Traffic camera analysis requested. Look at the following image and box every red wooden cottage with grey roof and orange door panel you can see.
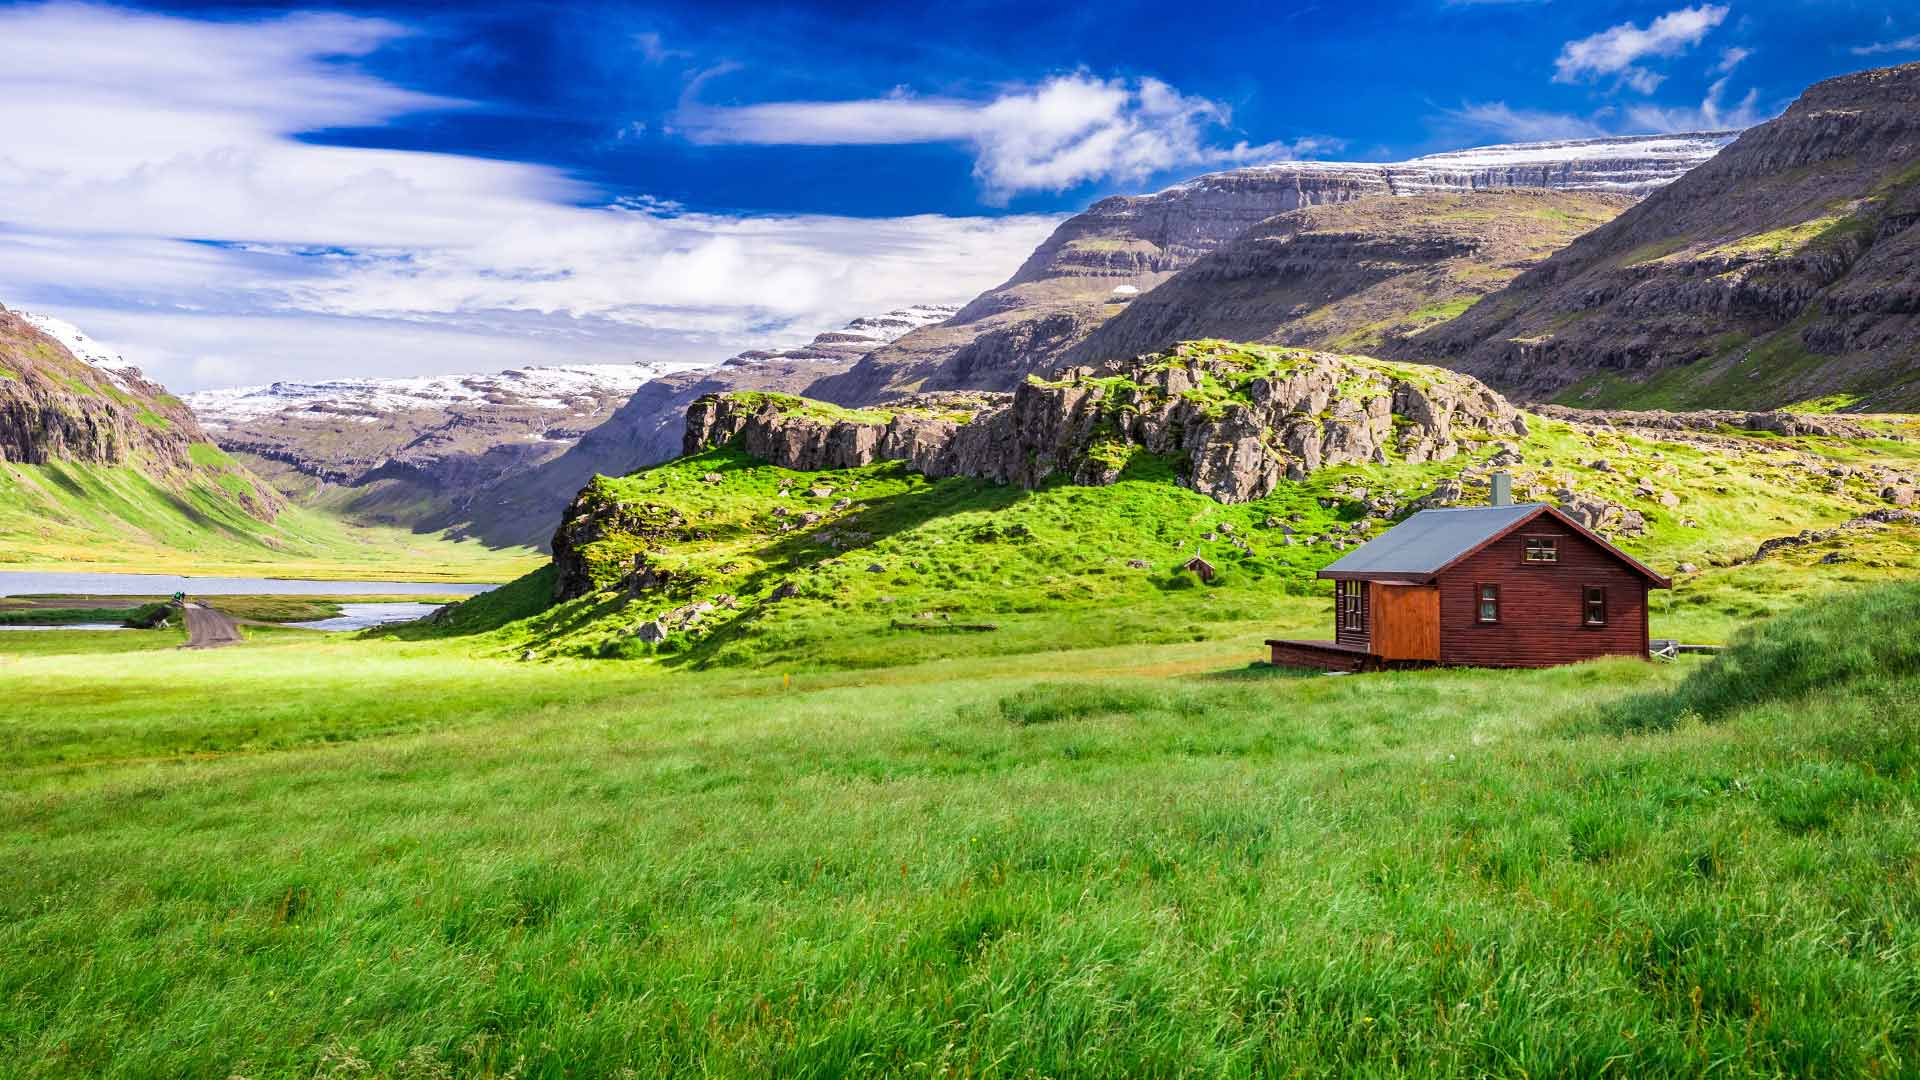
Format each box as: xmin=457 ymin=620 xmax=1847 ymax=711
xmin=1267 ymin=503 xmax=1672 ymax=671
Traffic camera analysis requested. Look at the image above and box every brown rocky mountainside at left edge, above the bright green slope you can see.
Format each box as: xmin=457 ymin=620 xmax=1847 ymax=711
xmin=0 ymin=307 xmax=284 ymax=521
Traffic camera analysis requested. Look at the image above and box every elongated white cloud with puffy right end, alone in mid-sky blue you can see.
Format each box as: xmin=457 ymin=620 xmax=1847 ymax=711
xmin=678 ymin=73 xmax=1336 ymax=202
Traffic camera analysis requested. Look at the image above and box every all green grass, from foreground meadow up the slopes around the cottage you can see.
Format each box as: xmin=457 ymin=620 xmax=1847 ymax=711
xmin=11 ymin=368 xmax=1920 ymax=1080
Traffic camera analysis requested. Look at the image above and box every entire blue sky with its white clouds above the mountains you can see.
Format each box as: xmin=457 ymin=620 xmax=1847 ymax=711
xmin=0 ymin=0 xmax=1920 ymax=388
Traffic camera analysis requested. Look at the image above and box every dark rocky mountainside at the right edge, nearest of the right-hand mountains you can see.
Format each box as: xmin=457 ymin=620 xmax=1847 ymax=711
xmin=1421 ymin=65 xmax=1920 ymax=409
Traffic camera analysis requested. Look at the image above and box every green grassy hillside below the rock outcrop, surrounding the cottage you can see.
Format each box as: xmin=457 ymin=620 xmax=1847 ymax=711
xmin=461 ymin=390 xmax=1920 ymax=671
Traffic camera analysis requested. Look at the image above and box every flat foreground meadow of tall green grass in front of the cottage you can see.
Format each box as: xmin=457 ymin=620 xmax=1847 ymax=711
xmin=0 ymin=586 xmax=1920 ymax=1078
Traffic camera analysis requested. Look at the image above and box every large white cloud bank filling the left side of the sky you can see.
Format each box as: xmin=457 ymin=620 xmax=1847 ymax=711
xmin=0 ymin=4 xmax=1056 ymax=390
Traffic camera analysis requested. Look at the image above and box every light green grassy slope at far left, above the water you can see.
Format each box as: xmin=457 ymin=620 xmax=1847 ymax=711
xmin=0 ymin=448 xmax=540 ymax=580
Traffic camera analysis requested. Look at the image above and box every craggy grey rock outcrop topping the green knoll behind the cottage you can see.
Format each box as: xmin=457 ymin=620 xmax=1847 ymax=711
xmin=685 ymin=342 xmax=1526 ymax=502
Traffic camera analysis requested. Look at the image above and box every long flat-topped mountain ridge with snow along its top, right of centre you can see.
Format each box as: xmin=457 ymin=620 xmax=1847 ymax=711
xmin=806 ymin=133 xmax=1730 ymax=404
